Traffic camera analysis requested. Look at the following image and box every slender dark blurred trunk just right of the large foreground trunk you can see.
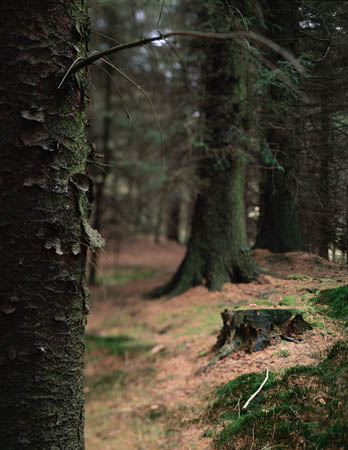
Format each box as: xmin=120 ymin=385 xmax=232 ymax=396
xmin=88 ymin=75 xmax=112 ymax=284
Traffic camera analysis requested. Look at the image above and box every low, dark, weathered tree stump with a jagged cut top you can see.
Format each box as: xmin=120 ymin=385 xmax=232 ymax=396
xmin=213 ymin=309 xmax=312 ymax=356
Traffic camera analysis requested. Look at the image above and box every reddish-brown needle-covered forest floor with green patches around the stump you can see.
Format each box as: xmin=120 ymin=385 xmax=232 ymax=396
xmin=85 ymin=237 xmax=348 ymax=450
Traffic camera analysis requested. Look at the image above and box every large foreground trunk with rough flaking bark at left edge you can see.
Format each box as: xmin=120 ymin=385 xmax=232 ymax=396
xmin=0 ymin=0 xmax=93 ymax=450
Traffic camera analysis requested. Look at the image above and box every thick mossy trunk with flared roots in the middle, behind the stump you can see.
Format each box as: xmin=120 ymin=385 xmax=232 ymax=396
xmin=150 ymin=2 xmax=256 ymax=296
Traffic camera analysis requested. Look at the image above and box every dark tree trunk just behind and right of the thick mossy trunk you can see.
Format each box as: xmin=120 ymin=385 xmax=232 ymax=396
xmin=255 ymin=0 xmax=304 ymax=253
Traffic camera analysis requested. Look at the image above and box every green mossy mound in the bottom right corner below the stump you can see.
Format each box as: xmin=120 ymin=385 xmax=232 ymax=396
xmin=206 ymin=342 xmax=348 ymax=450
